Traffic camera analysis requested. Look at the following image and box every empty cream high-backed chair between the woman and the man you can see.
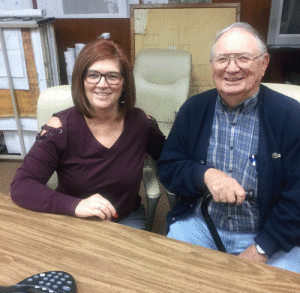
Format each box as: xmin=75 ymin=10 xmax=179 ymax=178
xmin=134 ymin=48 xmax=192 ymax=229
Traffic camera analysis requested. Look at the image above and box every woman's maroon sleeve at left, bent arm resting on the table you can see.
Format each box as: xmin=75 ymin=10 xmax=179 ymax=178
xmin=10 ymin=125 xmax=80 ymax=215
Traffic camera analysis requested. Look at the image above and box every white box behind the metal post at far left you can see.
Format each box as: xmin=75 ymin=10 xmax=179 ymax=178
xmin=0 ymin=118 xmax=38 ymax=154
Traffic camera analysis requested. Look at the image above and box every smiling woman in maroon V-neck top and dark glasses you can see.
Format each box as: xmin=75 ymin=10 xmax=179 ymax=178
xmin=11 ymin=39 xmax=165 ymax=228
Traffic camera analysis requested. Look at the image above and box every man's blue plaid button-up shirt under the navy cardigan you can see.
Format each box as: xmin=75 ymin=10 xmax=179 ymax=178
xmin=196 ymin=93 xmax=259 ymax=232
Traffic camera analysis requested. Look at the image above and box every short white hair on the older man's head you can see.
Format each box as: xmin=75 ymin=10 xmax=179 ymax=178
xmin=210 ymin=22 xmax=267 ymax=59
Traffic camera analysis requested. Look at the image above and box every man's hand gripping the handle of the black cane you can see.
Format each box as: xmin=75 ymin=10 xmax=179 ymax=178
xmin=204 ymin=168 xmax=246 ymax=205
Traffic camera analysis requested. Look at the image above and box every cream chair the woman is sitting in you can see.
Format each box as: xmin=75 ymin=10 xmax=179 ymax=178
xmin=37 ymin=85 xmax=159 ymax=231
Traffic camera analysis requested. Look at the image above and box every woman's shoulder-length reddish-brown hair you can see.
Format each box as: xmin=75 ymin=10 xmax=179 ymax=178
xmin=71 ymin=38 xmax=136 ymax=118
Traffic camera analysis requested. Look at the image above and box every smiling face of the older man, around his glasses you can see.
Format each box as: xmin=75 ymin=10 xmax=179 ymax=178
xmin=211 ymin=28 xmax=269 ymax=107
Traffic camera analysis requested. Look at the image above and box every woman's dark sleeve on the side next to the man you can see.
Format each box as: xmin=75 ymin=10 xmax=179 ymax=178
xmin=147 ymin=117 xmax=166 ymax=161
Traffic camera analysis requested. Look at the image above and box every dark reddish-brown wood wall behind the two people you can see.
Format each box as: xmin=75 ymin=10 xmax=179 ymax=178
xmin=54 ymin=0 xmax=274 ymax=84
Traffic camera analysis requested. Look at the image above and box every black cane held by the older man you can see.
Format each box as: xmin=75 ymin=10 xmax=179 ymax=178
xmin=201 ymin=190 xmax=254 ymax=252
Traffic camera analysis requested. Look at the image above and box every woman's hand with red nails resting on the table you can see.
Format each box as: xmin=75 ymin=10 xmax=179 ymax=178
xmin=75 ymin=193 xmax=118 ymax=220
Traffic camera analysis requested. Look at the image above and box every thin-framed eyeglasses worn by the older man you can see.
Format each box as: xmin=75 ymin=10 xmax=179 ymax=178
xmin=211 ymin=53 xmax=265 ymax=70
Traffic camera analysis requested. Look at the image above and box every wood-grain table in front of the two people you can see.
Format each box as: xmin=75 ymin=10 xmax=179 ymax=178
xmin=0 ymin=194 xmax=300 ymax=293
